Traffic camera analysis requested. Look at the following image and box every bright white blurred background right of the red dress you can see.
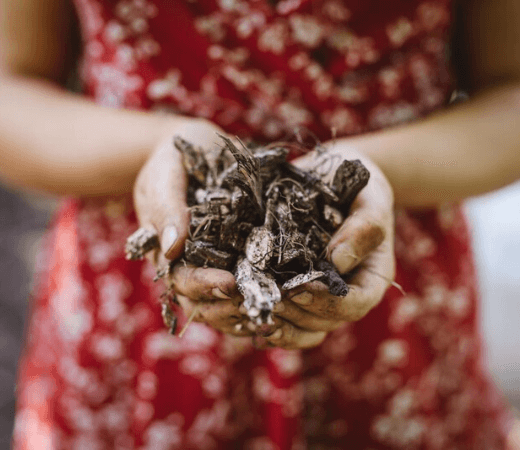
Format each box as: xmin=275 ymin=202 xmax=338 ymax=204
xmin=466 ymin=183 xmax=520 ymax=407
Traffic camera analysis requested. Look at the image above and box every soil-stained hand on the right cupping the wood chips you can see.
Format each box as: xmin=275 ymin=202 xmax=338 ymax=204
xmin=266 ymin=144 xmax=395 ymax=349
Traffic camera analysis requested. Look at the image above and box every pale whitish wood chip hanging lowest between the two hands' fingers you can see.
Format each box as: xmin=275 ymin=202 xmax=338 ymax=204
xmin=235 ymin=258 xmax=282 ymax=325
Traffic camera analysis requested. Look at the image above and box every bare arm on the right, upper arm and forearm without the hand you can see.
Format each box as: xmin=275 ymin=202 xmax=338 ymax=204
xmin=336 ymin=0 xmax=520 ymax=207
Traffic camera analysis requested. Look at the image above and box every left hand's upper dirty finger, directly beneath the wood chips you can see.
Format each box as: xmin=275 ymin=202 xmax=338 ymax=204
xmin=169 ymin=263 xmax=241 ymax=303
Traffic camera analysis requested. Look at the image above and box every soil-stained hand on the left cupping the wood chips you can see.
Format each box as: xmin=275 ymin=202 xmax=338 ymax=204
xmin=134 ymin=119 xmax=251 ymax=336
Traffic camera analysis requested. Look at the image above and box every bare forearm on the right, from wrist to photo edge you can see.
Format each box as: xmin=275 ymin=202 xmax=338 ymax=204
xmin=336 ymin=85 xmax=520 ymax=207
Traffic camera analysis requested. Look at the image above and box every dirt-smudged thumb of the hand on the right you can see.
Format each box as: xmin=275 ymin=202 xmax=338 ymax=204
xmin=327 ymin=199 xmax=386 ymax=273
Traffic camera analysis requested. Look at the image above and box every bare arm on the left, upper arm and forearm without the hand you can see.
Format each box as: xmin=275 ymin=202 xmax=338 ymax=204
xmin=0 ymin=0 xmax=185 ymax=196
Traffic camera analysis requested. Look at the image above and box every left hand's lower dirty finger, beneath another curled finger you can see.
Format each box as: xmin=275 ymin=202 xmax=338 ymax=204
xmin=177 ymin=295 xmax=253 ymax=336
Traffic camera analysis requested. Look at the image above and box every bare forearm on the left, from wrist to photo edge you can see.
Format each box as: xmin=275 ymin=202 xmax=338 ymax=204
xmin=0 ymin=77 xmax=186 ymax=196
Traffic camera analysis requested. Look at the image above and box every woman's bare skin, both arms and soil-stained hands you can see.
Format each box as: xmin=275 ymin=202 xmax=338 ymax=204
xmin=0 ymin=0 xmax=520 ymax=348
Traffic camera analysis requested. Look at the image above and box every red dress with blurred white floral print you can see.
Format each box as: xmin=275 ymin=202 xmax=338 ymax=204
xmin=14 ymin=0 xmax=509 ymax=450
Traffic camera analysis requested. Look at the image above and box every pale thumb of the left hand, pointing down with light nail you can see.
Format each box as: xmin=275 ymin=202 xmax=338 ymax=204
xmin=134 ymin=139 xmax=189 ymax=259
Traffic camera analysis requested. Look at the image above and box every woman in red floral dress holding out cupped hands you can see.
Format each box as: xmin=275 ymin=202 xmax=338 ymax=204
xmin=0 ymin=0 xmax=520 ymax=449
